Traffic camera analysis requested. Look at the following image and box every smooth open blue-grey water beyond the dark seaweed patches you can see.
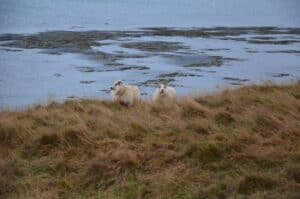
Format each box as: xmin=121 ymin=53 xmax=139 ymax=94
xmin=0 ymin=0 xmax=300 ymax=33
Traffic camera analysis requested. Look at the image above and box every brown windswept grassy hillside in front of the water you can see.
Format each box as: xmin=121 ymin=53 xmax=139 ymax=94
xmin=0 ymin=83 xmax=300 ymax=199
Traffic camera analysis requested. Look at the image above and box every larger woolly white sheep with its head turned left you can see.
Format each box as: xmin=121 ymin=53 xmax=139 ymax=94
xmin=111 ymin=80 xmax=141 ymax=106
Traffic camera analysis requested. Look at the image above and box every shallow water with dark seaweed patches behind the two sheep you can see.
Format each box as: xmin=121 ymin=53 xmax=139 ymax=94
xmin=0 ymin=27 xmax=300 ymax=107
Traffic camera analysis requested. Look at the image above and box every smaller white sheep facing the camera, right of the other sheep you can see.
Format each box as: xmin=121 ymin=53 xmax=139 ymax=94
xmin=152 ymin=84 xmax=176 ymax=101
